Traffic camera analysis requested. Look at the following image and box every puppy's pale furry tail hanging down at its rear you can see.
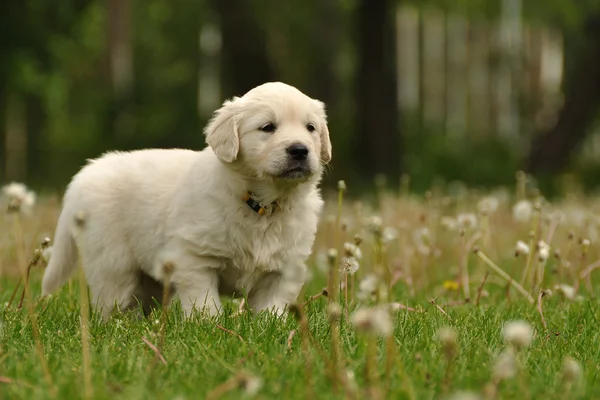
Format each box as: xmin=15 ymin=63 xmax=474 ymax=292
xmin=42 ymin=210 xmax=78 ymax=296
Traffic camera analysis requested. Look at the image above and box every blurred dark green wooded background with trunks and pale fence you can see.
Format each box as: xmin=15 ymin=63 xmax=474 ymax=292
xmin=0 ymin=0 xmax=600 ymax=193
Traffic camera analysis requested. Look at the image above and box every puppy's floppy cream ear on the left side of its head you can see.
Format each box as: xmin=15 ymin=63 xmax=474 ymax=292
xmin=204 ymin=97 xmax=240 ymax=162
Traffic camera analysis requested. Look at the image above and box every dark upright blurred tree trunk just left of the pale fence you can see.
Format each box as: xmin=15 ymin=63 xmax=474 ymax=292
xmin=354 ymin=0 xmax=401 ymax=179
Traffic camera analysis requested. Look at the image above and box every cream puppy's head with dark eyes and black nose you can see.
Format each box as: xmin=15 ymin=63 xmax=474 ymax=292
xmin=204 ymin=82 xmax=331 ymax=182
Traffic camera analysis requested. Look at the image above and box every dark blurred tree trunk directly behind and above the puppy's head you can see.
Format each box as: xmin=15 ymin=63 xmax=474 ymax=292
xmin=210 ymin=0 xmax=274 ymax=98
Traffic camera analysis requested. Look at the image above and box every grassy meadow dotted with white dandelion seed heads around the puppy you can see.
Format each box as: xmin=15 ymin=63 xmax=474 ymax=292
xmin=0 ymin=173 xmax=600 ymax=400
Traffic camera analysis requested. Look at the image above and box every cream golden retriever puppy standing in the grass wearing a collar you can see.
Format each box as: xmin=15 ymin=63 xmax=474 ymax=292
xmin=42 ymin=82 xmax=331 ymax=318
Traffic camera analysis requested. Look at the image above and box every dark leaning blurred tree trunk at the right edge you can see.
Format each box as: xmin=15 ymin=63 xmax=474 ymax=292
xmin=525 ymin=15 xmax=600 ymax=174
